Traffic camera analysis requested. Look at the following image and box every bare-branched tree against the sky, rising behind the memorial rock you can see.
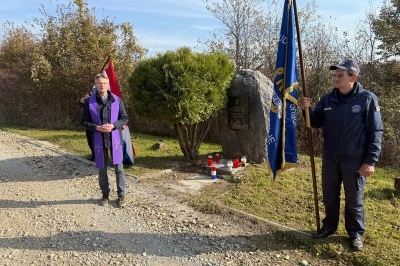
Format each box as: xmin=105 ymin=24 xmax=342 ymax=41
xmin=203 ymin=0 xmax=268 ymax=70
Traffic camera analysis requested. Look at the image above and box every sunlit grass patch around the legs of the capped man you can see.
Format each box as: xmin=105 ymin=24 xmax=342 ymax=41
xmin=209 ymin=155 xmax=400 ymax=265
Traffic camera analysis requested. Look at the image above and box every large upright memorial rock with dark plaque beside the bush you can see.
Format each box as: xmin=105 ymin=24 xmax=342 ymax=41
xmin=217 ymin=70 xmax=273 ymax=163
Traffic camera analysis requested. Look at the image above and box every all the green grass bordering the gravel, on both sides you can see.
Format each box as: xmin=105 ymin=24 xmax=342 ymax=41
xmin=0 ymin=126 xmax=400 ymax=266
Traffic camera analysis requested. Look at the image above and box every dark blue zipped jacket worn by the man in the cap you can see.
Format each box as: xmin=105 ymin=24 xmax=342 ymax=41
xmin=310 ymin=82 xmax=383 ymax=165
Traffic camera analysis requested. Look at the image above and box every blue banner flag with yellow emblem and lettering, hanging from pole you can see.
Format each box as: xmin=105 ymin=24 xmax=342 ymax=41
xmin=266 ymin=0 xmax=299 ymax=179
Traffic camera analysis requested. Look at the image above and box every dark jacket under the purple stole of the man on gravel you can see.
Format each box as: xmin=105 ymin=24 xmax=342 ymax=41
xmin=81 ymin=91 xmax=128 ymax=148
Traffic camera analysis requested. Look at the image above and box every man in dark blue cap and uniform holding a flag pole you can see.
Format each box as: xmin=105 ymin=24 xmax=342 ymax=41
xmin=300 ymin=60 xmax=383 ymax=250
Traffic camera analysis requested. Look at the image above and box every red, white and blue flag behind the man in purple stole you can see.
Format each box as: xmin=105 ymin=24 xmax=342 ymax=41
xmin=105 ymin=59 xmax=136 ymax=165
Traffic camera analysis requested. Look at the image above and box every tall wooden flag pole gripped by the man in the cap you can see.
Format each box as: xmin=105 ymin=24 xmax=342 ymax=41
xmin=292 ymin=0 xmax=321 ymax=232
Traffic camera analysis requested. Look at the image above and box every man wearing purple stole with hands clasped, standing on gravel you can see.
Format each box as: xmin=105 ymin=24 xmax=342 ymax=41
xmin=81 ymin=74 xmax=128 ymax=207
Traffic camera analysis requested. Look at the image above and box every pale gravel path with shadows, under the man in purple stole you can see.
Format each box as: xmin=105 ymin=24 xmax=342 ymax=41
xmin=0 ymin=131 xmax=336 ymax=266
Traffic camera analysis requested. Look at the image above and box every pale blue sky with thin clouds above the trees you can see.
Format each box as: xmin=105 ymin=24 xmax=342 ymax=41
xmin=0 ymin=0 xmax=384 ymax=56
